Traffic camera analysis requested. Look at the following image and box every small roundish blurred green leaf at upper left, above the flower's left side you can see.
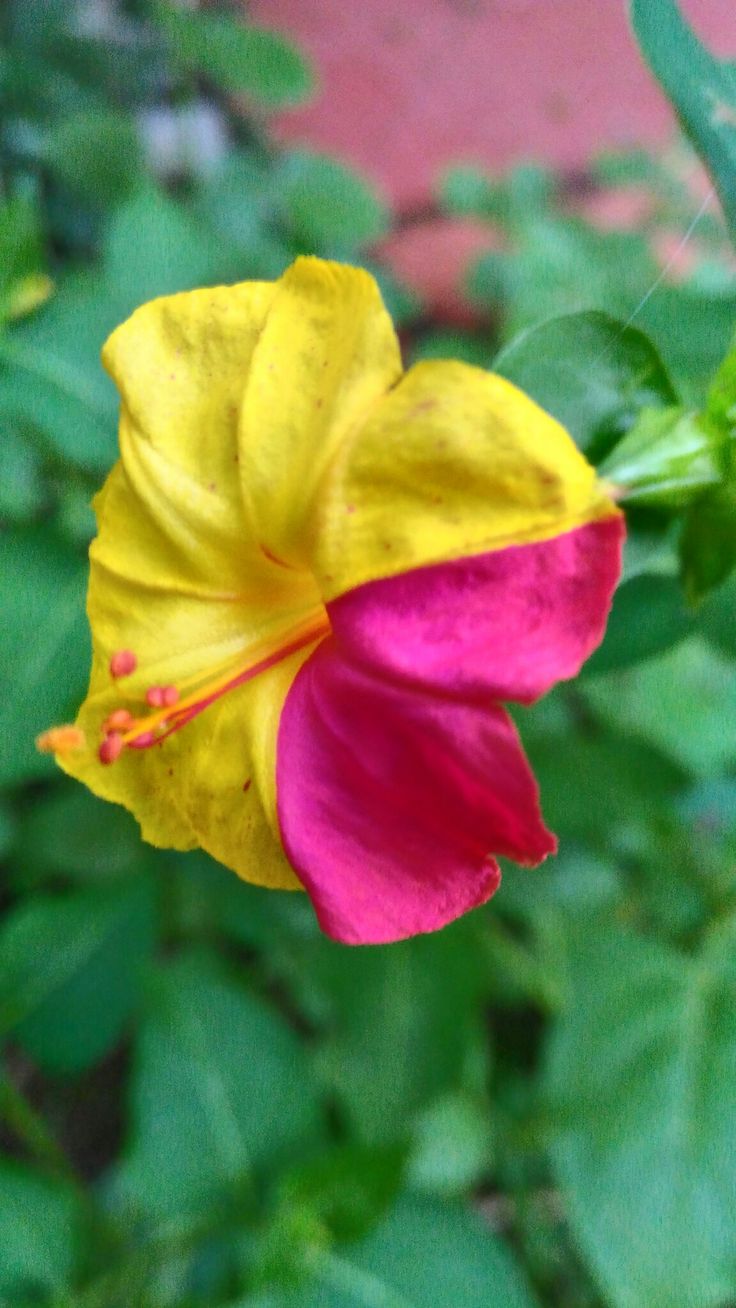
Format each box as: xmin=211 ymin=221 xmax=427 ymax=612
xmin=43 ymin=110 xmax=144 ymax=208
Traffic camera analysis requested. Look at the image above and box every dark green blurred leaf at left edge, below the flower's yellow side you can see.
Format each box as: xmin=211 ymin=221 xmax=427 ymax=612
xmin=0 ymin=879 xmax=154 ymax=1073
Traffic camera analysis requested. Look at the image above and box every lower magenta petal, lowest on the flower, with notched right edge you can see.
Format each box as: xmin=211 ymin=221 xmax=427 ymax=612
xmin=277 ymin=638 xmax=554 ymax=944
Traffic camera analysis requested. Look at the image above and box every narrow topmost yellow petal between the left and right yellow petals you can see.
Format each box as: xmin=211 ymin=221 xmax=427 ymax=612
xmin=241 ymin=259 xmax=401 ymax=566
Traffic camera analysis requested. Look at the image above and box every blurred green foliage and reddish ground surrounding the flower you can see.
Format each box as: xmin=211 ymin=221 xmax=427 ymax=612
xmin=0 ymin=0 xmax=736 ymax=1308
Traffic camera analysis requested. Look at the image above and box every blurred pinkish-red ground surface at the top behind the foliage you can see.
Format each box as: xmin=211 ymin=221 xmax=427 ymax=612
xmin=248 ymin=0 xmax=736 ymax=313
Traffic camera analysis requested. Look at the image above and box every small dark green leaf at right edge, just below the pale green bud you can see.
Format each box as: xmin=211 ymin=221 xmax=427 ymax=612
xmin=680 ymin=480 xmax=736 ymax=603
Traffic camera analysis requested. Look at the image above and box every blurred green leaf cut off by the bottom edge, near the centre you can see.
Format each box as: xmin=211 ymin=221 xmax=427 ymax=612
xmin=270 ymin=1198 xmax=537 ymax=1308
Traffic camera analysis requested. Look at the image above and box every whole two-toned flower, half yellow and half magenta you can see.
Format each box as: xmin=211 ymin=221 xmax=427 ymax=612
xmin=44 ymin=258 xmax=624 ymax=943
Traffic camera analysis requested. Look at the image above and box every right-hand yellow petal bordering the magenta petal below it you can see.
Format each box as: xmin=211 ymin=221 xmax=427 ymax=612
xmin=312 ymin=361 xmax=617 ymax=599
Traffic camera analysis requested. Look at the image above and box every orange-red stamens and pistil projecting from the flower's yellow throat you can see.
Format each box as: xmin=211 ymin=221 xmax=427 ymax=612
xmin=98 ymin=610 xmax=329 ymax=764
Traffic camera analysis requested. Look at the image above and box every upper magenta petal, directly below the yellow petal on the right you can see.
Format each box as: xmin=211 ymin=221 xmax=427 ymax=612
xmin=329 ymin=515 xmax=624 ymax=704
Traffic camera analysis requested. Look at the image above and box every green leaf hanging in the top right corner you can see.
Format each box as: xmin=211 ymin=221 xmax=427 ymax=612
xmin=631 ymin=0 xmax=736 ymax=241
